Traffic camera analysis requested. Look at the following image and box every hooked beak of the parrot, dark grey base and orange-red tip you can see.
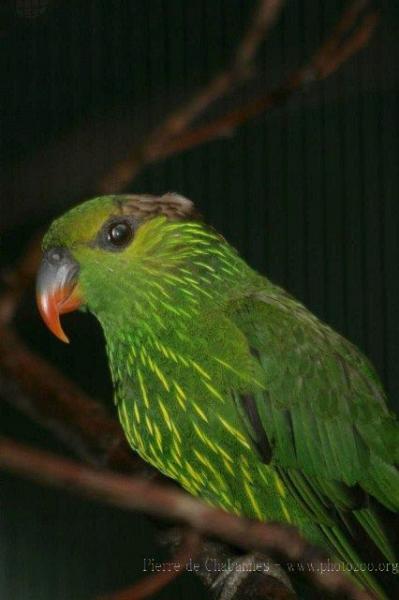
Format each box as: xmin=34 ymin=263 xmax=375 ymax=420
xmin=36 ymin=247 xmax=82 ymax=343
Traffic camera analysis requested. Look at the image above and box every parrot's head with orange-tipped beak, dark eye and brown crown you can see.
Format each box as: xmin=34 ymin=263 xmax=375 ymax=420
xmin=37 ymin=193 xmax=230 ymax=342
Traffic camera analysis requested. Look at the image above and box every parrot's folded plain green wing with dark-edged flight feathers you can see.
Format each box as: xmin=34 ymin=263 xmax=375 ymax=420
xmin=230 ymin=287 xmax=399 ymax=595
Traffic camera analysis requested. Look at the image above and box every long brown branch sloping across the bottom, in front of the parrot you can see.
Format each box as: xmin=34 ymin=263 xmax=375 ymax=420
xmin=0 ymin=437 xmax=372 ymax=600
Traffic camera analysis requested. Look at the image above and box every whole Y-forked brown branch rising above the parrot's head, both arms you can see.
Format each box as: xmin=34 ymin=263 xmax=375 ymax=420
xmin=98 ymin=0 xmax=379 ymax=193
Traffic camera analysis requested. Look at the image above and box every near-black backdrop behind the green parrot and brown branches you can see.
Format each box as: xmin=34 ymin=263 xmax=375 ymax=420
xmin=0 ymin=0 xmax=399 ymax=600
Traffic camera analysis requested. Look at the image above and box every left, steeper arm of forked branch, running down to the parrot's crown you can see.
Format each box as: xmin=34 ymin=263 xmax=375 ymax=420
xmin=99 ymin=0 xmax=284 ymax=193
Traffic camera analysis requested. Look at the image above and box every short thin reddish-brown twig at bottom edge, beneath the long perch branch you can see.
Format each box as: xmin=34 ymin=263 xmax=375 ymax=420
xmin=98 ymin=530 xmax=202 ymax=600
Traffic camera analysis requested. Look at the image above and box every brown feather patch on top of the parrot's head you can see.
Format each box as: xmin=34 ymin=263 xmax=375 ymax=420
xmin=115 ymin=193 xmax=201 ymax=221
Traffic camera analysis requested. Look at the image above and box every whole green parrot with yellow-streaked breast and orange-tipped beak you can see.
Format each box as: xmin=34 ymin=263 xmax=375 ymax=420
xmin=37 ymin=193 xmax=399 ymax=598
